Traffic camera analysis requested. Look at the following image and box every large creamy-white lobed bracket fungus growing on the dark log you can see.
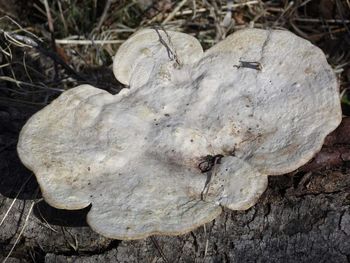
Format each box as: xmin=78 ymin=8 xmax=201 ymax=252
xmin=18 ymin=29 xmax=341 ymax=239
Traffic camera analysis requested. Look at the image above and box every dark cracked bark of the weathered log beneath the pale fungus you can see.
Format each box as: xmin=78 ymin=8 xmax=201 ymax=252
xmin=0 ymin=108 xmax=350 ymax=262
